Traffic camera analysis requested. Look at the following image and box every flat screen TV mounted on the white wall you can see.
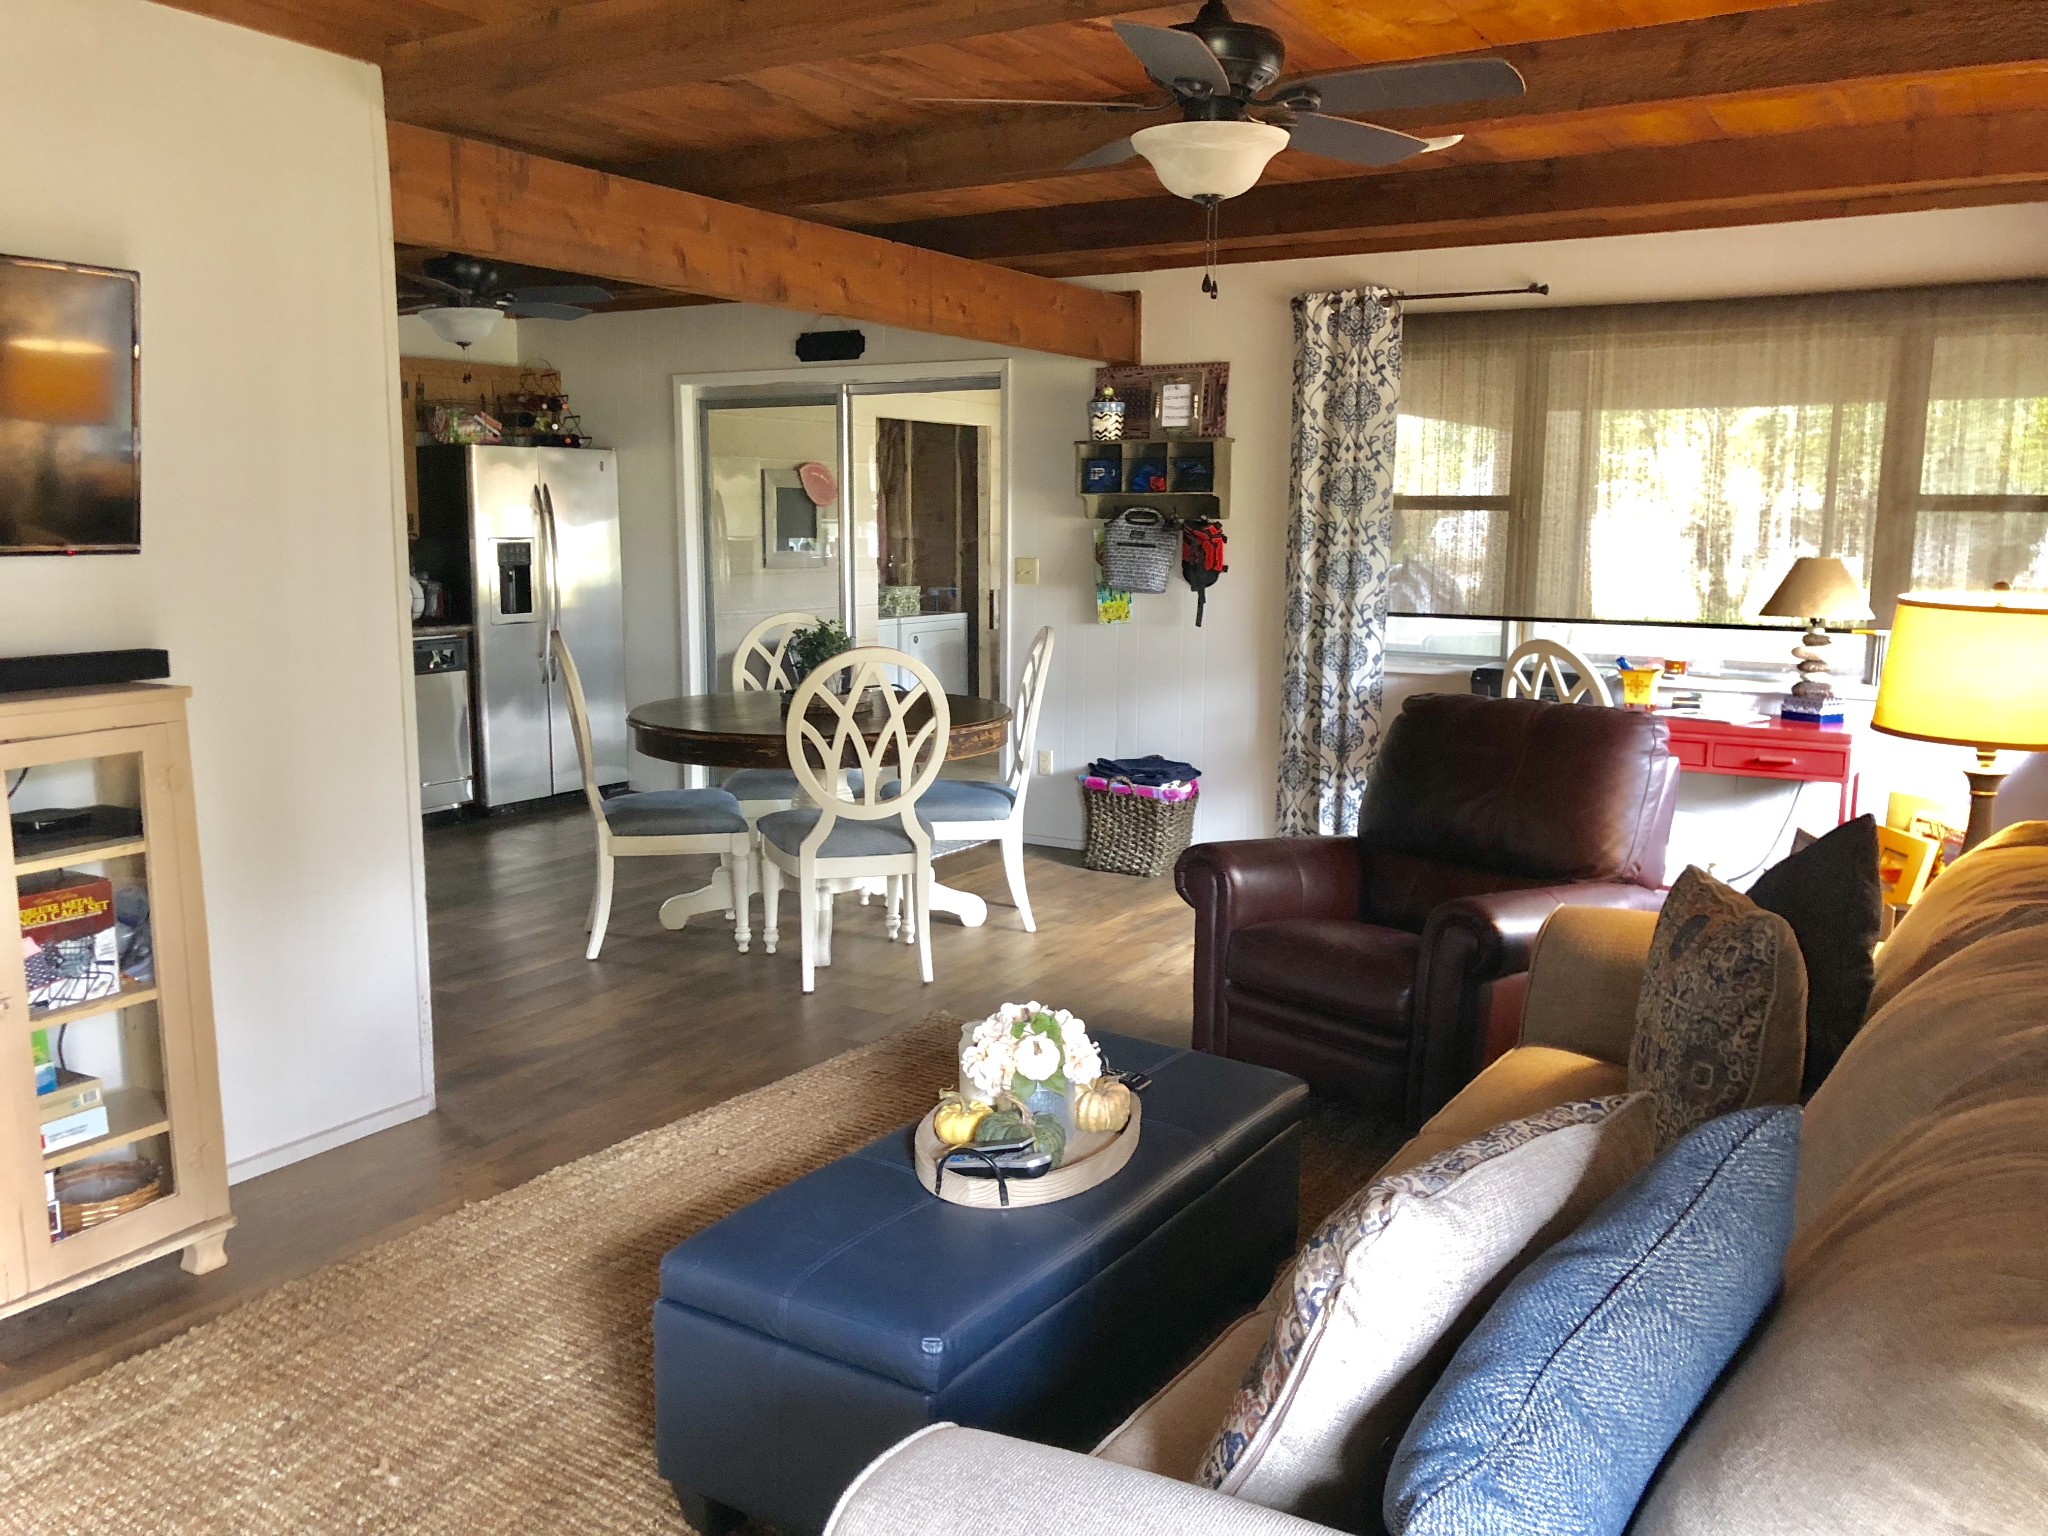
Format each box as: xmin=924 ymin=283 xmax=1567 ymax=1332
xmin=0 ymin=256 xmax=141 ymax=555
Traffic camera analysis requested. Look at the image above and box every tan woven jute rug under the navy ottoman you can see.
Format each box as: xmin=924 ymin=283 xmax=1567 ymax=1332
xmin=0 ymin=1016 xmax=1399 ymax=1536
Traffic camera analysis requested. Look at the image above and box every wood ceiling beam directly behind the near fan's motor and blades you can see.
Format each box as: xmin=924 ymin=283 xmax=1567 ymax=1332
xmin=627 ymin=0 xmax=2048 ymax=209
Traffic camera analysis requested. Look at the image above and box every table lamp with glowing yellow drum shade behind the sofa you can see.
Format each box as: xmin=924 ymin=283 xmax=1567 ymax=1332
xmin=1870 ymin=588 xmax=2048 ymax=852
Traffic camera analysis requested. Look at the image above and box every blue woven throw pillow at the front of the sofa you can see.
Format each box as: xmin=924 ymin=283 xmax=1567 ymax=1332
xmin=1386 ymin=1108 xmax=1800 ymax=1536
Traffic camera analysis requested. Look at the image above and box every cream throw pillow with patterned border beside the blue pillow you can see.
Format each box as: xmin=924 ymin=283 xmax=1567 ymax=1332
xmin=1198 ymin=1094 xmax=1651 ymax=1524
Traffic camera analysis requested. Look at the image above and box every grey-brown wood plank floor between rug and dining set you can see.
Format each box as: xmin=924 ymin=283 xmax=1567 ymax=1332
xmin=0 ymin=807 xmax=1192 ymax=1409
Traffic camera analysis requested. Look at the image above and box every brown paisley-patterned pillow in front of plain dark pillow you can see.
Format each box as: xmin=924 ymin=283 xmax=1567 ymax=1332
xmin=1628 ymin=868 xmax=1806 ymax=1147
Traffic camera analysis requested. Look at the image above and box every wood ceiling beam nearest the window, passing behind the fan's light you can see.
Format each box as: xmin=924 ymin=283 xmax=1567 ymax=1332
xmin=889 ymin=113 xmax=2048 ymax=274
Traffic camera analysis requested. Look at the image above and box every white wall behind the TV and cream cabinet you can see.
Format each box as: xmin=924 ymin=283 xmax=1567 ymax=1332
xmin=0 ymin=0 xmax=432 ymax=1176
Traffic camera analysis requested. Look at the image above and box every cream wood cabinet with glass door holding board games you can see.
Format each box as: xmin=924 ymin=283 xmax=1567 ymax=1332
xmin=0 ymin=686 xmax=233 ymax=1317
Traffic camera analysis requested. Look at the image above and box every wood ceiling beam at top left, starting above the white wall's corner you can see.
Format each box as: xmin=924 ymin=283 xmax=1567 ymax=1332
xmin=385 ymin=0 xmax=1133 ymax=127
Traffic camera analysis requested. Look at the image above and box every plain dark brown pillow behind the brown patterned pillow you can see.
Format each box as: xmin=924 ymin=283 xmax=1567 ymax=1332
xmin=1749 ymin=815 xmax=1884 ymax=1098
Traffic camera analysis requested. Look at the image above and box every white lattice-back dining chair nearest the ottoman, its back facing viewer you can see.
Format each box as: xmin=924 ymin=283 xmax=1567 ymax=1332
xmin=760 ymin=645 xmax=952 ymax=991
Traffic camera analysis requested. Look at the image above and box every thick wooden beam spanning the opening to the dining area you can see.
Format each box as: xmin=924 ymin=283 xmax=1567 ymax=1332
xmin=389 ymin=123 xmax=1139 ymax=362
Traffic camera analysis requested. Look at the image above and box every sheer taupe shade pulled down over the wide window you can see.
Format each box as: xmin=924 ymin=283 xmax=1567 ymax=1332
xmin=1391 ymin=285 xmax=2048 ymax=633
